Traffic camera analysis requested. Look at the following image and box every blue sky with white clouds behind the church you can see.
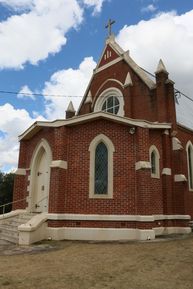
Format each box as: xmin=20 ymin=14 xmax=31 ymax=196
xmin=0 ymin=0 xmax=193 ymax=171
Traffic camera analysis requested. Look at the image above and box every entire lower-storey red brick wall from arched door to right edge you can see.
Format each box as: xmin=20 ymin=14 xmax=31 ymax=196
xmin=14 ymin=116 xmax=193 ymax=224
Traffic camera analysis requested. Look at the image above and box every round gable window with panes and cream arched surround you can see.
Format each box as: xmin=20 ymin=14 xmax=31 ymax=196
xmin=94 ymin=88 xmax=124 ymax=116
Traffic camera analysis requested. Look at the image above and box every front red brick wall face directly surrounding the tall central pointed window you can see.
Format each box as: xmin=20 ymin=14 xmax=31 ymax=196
xmin=65 ymin=120 xmax=135 ymax=214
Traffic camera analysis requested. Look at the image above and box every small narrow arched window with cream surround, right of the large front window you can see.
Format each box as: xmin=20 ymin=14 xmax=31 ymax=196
xmin=149 ymin=145 xmax=160 ymax=178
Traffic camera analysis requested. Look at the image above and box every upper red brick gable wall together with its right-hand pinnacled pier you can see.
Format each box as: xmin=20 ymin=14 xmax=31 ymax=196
xmin=79 ymin=60 xmax=176 ymax=129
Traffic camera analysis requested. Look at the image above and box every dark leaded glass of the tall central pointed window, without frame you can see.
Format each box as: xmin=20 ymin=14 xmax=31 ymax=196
xmin=94 ymin=142 xmax=108 ymax=194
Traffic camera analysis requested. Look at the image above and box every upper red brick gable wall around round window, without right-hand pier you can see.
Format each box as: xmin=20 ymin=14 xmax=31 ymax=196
xmin=79 ymin=61 xmax=161 ymax=121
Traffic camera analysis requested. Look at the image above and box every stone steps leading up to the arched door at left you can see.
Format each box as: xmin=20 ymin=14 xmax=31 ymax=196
xmin=0 ymin=213 xmax=36 ymax=244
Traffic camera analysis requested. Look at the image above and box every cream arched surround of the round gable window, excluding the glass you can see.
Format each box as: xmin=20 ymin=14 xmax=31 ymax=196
xmin=94 ymin=87 xmax=124 ymax=116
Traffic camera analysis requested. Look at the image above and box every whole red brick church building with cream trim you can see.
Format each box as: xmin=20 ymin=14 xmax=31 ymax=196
xmin=13 ymin=34 xmax=193 ymax=243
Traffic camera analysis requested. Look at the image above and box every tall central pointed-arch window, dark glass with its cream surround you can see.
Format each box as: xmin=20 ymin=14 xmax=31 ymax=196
xmin=89 ymin=134 xmax=114 ymax=198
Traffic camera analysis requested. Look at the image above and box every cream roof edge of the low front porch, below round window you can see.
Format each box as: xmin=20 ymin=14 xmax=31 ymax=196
xmin=19 ymin=112 xmax=171 ymax=141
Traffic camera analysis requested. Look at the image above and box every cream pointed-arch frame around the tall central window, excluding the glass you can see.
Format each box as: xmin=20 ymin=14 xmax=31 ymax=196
xmin=89 ymin=134 xmax=115 ymax=199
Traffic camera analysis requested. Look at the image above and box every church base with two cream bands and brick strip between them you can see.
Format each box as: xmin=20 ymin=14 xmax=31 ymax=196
xmin=47 ymin=214 xmax=191 ymax=241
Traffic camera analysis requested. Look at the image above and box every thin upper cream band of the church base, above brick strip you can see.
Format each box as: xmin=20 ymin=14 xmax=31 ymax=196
xmin=47 ymin=213 xmax=191 ymax=222
